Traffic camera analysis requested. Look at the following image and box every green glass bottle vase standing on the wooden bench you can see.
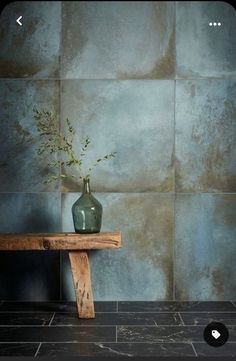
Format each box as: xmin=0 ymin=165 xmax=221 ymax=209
xmin=72 ymin=179 xmax=102 ymax=233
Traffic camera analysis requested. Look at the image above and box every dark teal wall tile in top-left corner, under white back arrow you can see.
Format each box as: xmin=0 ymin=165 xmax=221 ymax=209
xmin=0 ymin=1 xmax=61 ymax=79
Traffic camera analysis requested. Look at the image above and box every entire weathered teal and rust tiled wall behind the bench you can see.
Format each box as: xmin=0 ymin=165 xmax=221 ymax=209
xmin=0 ymin=1 xmax=236 ymax=300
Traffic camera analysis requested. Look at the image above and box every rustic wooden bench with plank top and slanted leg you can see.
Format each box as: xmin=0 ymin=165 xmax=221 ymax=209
xmin=0 ymin=232 xmax=121 ymax=318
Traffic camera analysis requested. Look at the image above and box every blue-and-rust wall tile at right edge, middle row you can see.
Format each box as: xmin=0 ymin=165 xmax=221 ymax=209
xmin=175 ymin=79 xmax=236 ymax=192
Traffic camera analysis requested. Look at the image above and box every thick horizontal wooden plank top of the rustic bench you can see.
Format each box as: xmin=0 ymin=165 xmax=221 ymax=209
xmin=0 ymin=232 xmax=121 ymax=251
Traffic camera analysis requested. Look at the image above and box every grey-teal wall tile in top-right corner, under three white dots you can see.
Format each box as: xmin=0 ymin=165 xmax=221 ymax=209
xmin=176 ymin=1 xmax=236 ymax=78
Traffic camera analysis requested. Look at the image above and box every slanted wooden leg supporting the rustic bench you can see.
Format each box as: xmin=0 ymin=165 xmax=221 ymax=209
xmin=69 ymin=251 xmax=95 ymax=318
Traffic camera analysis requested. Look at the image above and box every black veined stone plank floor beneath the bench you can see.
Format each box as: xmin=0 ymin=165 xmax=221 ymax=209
xmin=0 ymin=301 xmax=236 ymax=357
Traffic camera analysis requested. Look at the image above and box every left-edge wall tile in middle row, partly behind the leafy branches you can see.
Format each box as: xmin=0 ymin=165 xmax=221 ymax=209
xmin=0 ymin=79 xmax=59 ymax=192
